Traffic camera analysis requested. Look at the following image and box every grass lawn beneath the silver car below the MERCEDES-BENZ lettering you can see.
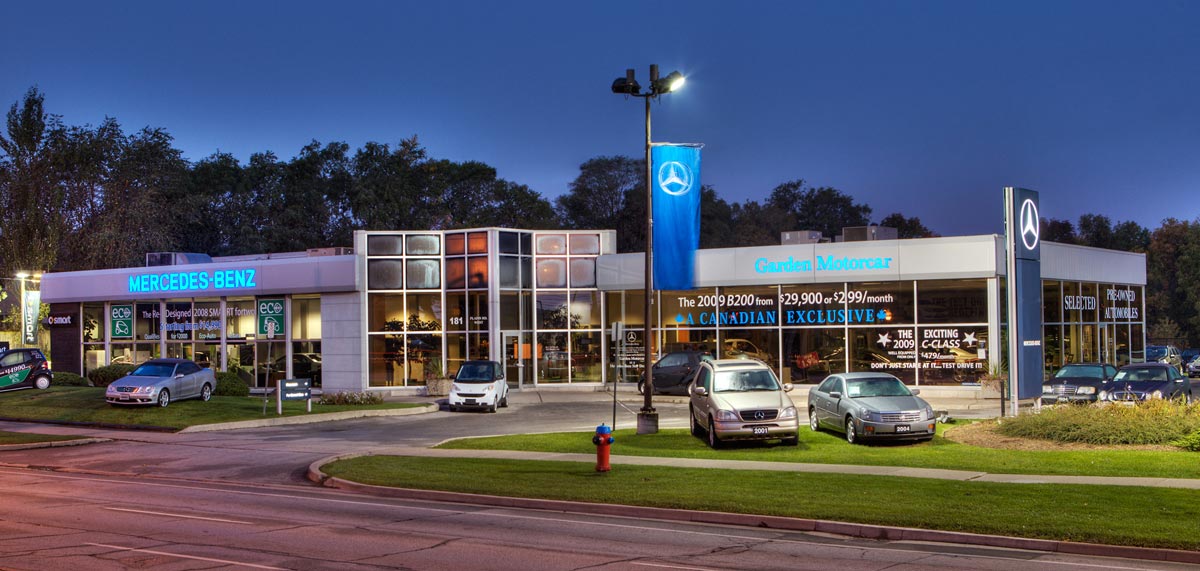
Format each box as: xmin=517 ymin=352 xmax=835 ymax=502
xmin=0 ymin=386 xmax=420 ymax=429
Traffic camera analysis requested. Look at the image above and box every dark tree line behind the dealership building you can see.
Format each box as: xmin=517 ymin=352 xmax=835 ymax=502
xmin=0 ymin=88 xmax=1200 ymax=344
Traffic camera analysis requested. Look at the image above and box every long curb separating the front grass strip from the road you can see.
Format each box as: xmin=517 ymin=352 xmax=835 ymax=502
xmin=306 ymin=452 xmax=1200 ymax=564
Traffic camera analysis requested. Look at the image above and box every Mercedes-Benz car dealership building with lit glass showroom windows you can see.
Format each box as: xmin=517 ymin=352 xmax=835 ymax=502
xmin=41 ymin=228 xmax=1146 ymax=393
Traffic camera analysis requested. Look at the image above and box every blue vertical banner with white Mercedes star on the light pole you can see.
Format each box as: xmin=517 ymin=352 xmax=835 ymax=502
xmin=650 ymin=144 xmax=701 ymax=289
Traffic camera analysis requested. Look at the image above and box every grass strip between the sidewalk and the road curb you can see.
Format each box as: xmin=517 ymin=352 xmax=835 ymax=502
xmin=323 ymin=455 xmax=1200 ymax=549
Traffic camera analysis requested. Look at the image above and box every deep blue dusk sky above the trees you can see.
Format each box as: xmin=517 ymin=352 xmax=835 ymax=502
xmin=0 ymin=0 xmax=1200 ymax=235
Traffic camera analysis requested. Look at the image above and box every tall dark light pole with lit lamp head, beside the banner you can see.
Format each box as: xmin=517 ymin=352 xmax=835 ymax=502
xmin=612 ymin=64 xmax=684 ymax=434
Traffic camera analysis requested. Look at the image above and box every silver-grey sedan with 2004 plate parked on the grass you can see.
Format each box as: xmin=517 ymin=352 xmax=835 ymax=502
xmin=809 ymin=373 xmax=937 ymax=444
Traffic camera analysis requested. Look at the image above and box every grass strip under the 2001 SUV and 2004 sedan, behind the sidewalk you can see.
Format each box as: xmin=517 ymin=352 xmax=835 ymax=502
xmin=439 ymin=423 xmax=1200 ymax=479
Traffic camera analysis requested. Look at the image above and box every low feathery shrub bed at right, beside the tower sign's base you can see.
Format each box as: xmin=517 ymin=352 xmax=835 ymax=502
xmin=997 ymin=399 xmax=1200 ymax=445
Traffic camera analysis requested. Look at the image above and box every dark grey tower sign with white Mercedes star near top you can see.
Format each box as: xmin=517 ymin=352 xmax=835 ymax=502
xmin=1004 ymin=187 xmax=1044 ymax=416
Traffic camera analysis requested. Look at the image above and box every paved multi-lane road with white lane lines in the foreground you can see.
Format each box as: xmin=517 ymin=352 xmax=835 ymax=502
xmin=0 ymin=468 xmax=1200 ymax=571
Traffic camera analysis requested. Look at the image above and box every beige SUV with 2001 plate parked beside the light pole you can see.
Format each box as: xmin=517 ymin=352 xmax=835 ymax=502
xmin=688 ymin=359 xmax=800 ymax=449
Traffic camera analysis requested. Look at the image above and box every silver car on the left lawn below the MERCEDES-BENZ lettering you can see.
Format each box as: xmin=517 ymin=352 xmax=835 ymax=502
xmin=104 ymin=359 xmax=217 ymax=407
